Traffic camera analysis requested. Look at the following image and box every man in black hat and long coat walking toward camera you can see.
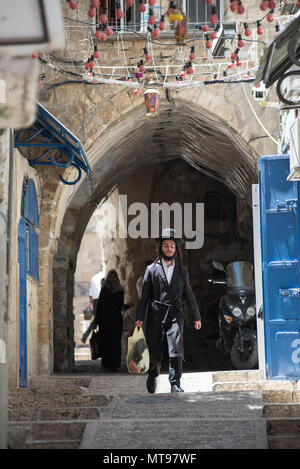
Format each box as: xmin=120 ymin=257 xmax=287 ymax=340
xmin=136 ymin=228 xmax=201 ymax=393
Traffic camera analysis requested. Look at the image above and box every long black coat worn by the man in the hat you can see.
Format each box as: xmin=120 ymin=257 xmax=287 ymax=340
xmin=136 ymin=259 xmax=201 ymax=359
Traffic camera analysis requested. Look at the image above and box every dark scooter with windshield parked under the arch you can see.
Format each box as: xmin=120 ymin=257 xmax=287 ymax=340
xmin=208 ymin=261 xmax=258 ymax=370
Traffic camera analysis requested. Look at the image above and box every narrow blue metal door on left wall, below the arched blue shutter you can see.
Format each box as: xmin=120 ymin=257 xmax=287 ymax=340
xmin=18 ymin=218 xmax=27 ymax=387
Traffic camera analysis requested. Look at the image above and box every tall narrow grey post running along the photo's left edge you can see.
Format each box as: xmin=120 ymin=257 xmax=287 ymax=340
xmin=0 ymin=130 xmax=14 ymax=449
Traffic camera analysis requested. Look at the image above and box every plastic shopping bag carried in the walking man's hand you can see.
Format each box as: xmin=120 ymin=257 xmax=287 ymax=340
xmin=126 ymin=327 xmax=150 ymax=374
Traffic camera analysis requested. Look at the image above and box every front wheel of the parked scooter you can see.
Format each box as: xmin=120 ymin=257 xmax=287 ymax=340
xmin=231 ymin=329 xmax=258 ymax=370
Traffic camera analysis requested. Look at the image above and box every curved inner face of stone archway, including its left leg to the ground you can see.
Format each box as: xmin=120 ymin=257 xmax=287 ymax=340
xmin=53 ymin=100 xmax=256 ymax=371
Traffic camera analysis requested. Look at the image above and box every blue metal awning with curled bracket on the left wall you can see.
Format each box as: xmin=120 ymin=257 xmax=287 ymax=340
xmin=15 ymin=103 xmax=91 ymax=185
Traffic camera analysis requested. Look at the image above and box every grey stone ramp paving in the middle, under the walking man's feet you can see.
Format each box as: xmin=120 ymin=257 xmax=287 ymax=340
xmin=79 ymin=372 xmax=268 ymax=450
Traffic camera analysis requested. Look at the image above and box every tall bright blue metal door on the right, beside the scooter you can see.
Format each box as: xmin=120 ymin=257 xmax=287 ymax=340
xmin=258 ymin=155 xmax=300 ymax=380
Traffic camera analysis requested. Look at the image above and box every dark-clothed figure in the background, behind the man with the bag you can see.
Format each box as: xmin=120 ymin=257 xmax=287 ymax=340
xmin=94 ymin=270 xmax=131 ymax=370
